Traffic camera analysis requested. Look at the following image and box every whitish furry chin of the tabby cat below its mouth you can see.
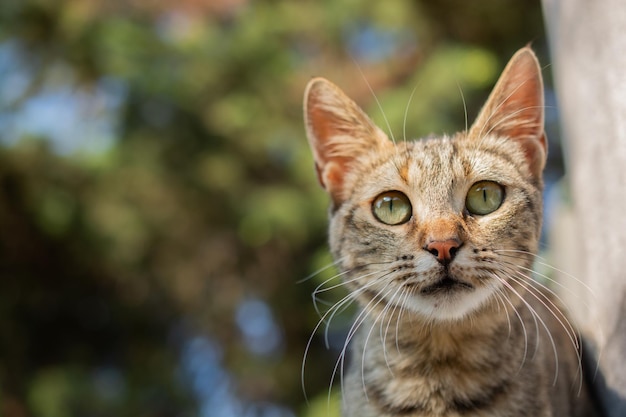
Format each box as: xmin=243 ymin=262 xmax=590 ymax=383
xmin=404 ymin=277 xmax=492 ymax=321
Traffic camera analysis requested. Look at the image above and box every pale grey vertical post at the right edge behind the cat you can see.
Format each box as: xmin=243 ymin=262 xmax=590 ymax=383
xmin=543 ymin=0 xmax=626 ymax=417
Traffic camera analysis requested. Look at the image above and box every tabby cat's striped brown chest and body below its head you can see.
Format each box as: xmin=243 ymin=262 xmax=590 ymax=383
xmin=343 ymin=296 xmax=572 ymax=417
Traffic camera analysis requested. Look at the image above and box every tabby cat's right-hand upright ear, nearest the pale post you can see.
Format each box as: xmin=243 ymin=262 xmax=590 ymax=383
xmin=469 ymin=47 xmax=547 ymax=177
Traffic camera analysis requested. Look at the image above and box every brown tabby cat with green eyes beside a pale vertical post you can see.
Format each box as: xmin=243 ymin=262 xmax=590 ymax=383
xmin=304 ymin=47 xmax=597 ymax=417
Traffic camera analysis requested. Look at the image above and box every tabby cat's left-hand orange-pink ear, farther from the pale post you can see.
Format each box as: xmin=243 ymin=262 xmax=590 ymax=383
xmin=304 ymin=78 xmax=391 ymax=204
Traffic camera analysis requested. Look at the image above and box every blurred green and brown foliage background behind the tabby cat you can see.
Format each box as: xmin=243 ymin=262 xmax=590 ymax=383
xmin=0 ymin=0 xmax=562 ymax=417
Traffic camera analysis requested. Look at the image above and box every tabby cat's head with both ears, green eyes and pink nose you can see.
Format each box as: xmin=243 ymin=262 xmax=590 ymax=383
xmin=304 ymin=48 xmax=547 ymax=320
